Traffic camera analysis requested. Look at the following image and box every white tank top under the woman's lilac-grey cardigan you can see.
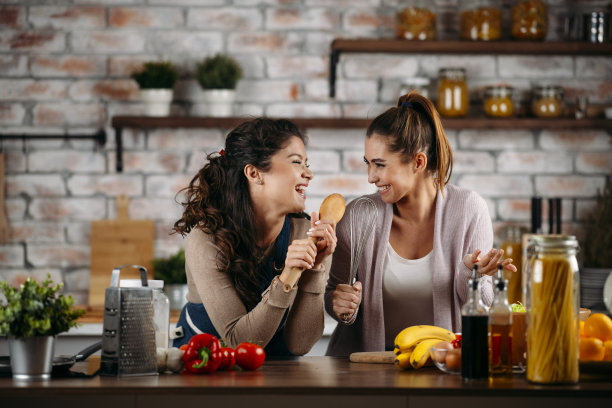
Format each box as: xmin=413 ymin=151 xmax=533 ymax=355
xmin=383 ymin=243 xmax=434 ymax=349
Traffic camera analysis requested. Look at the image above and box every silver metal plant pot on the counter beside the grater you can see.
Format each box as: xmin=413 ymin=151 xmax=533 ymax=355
xmin=8 ymin=336 xmax=55 ymax=380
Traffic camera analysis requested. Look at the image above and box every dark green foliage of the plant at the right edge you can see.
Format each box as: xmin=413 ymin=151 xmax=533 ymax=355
xmin=582 ymin=181 xmax=612 ymax=268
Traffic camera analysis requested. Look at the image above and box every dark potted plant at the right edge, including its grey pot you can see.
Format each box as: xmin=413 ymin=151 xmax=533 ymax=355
xmin=580 ymin=182 xmax=612 ymax=310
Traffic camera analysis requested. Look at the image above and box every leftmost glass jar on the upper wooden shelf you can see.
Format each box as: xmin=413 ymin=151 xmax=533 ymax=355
xmin=395 ymin=0 xmax=436 ymax=40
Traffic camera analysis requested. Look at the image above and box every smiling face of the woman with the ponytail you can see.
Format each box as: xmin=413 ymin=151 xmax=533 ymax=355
xmin=363 ymin=134 xmax=416 ymax=204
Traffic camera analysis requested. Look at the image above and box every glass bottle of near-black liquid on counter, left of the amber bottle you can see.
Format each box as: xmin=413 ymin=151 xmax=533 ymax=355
xmin=461 ymin=265 xmax=489 ymax=380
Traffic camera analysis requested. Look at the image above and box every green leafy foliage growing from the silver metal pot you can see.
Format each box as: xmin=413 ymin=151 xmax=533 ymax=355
xmin=0 ymin=275 xmax=85 ymax=338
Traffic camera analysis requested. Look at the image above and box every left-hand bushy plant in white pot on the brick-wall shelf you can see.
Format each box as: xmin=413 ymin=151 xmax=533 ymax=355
xmin=132 ymin=61 xmax=178 ymax=116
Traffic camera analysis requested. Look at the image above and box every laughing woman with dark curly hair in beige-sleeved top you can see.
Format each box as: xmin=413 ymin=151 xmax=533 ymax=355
xmin=174 ymin=118 xmax=336 ymax=356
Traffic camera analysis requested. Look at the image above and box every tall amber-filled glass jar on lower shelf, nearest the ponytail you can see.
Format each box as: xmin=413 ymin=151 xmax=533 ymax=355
xmin=437 ymin=68 xmax=470 ymax=117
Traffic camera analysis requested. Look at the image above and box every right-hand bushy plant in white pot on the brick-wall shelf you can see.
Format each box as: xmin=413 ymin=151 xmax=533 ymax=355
xmin=194 ymin=54 xmax=242 ymax=116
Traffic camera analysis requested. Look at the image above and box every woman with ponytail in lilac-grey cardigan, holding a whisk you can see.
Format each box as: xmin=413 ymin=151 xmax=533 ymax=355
xmin=325 ymin=92 xmax=516 ymax=356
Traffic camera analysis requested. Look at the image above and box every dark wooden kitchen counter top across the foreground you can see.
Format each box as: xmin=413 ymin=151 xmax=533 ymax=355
xmin=0 ymin=356 xmax=612 ymax=408
